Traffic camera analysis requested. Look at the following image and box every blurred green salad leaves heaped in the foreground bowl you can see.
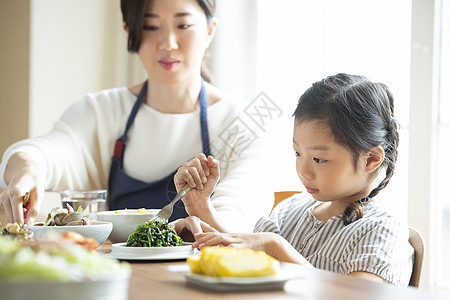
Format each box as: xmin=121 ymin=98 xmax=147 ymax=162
xmin=0 ymin=232 xmax=130 ymax=282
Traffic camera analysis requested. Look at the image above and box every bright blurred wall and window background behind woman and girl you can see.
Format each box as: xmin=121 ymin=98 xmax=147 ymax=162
xmin=0 ymin=0 xmax=450 ymax=293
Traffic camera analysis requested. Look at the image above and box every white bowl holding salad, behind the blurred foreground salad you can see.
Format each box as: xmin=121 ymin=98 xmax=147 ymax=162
xmin=27 ymin=221 xmax=113 ymax=244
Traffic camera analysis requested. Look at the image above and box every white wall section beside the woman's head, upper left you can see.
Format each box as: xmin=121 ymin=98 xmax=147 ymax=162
xmin=29 ymin=0 xmax=143 ymax=136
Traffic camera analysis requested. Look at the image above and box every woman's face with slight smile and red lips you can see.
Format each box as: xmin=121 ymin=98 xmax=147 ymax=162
xmin=138 ymin=0 xmax=216 ymax=83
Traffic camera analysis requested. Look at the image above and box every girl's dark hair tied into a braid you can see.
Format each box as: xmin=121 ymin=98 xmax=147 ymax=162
xmin=294 ymin=73 xmax=399 ymax=225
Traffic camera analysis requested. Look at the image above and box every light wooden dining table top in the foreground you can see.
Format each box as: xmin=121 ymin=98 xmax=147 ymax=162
xmin=97 ymin=240 xmax=449 ymax=300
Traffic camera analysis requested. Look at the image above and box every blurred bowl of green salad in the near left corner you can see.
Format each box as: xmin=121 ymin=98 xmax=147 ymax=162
xmin=0 ymin=231 xmax=131 ymax=300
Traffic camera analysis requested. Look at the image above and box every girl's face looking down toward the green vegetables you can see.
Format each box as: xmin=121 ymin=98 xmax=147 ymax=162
xmin=293 ymin=120 xmax=370 ymax=204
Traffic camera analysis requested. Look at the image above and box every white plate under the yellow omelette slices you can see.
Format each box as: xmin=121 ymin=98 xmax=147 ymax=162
xmin=185 ymin=263 xmax=295 ymax=292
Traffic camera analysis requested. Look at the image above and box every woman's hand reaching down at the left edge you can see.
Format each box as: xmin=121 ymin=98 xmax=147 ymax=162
xmin=0 ymin=153 xmax=44 ymax=225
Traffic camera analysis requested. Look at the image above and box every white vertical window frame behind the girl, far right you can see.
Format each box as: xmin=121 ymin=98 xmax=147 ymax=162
xmin=408 ymin=0 xmax=443 ymax=290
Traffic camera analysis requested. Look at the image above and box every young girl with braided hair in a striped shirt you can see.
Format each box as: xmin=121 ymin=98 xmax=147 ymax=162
xmin=174 ymin=74 xmax=414 ymax=286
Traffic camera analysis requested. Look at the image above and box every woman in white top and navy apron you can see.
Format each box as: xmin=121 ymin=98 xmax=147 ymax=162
xmin=0 ymin=0 xmax=270 ymax=231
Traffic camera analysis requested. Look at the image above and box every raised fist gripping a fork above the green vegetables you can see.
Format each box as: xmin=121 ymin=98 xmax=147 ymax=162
xmin=174 ymin=153 xmax=220 ymax=215
